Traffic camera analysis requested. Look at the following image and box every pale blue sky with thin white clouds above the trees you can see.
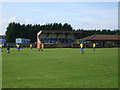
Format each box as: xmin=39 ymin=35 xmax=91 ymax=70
xmin=0 ymin=2 xmax=118 ymax=35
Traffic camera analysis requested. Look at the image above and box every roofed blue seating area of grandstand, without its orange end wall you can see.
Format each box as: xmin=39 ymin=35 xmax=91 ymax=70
xmin=39 ymin=30 xmax=81 ymax=44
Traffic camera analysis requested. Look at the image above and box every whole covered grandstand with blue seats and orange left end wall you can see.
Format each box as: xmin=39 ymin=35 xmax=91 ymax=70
xmin=37 ymin=30 xmax=81 ymax=48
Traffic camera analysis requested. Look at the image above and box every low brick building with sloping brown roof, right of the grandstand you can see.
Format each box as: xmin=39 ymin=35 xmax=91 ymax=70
xmin=78 ymin=35 xmax=120 ymax=47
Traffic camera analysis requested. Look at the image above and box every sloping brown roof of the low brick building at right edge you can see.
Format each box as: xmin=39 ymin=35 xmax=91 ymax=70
xmin=78 ymin=35 xmax=120 ymax=41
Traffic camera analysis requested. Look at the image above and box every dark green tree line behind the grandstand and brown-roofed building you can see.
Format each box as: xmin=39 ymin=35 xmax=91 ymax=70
xmin=6 ymin=22 xmax=119 ymax=43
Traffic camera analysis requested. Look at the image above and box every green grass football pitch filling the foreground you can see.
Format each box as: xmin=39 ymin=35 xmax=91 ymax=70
xmin=2 ymin=48 xmax=118 ymax=88
